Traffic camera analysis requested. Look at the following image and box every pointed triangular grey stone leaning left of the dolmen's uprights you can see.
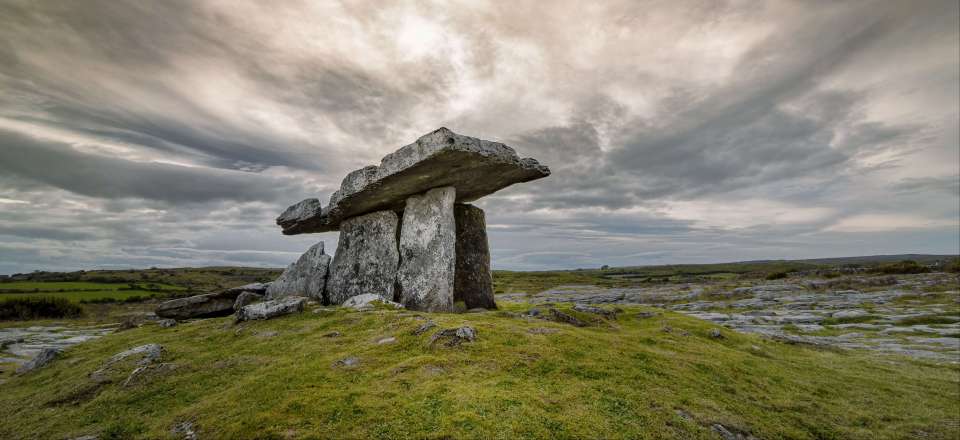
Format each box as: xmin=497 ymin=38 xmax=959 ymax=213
xmin=266 ymin=241 xmax=330 ymax=301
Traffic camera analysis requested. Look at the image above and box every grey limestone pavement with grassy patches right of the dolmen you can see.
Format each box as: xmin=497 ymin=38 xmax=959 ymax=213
xmin=497 ymin=273 xmax=960 ymax=363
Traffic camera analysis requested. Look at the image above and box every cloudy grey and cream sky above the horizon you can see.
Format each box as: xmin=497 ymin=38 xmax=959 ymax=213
xmin=0 ymin=0 xmax=960 ymax=274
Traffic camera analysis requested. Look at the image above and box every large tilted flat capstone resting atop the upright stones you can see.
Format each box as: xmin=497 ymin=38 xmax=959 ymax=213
xmin=277 ymin=128 xmax=550 ymax=235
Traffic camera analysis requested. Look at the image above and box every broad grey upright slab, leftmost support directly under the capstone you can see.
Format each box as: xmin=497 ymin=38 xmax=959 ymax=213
xmin=327 ymin=211 xmax=399 ymax=304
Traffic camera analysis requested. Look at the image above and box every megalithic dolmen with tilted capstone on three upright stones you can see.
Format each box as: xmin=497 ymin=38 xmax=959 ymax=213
xmin=277 ymin=128 xmax=550 ymax=312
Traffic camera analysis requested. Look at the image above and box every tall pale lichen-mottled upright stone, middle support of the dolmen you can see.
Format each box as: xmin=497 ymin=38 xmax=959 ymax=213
xmin=397 ymin=186 xmax=457 ymax=312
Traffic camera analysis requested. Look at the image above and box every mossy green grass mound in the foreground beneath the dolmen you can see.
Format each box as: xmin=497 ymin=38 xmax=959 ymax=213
xmin=0 ymin=304 xmax=960 ymax=439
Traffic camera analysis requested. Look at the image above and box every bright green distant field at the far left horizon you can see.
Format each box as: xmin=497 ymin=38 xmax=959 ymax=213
xmin=0 ymin=281 xmax=186 ymax=302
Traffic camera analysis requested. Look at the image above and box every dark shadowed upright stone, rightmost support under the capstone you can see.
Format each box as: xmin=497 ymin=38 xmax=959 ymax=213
xmin=453 ymin=203 xmax=497 ymax=309
